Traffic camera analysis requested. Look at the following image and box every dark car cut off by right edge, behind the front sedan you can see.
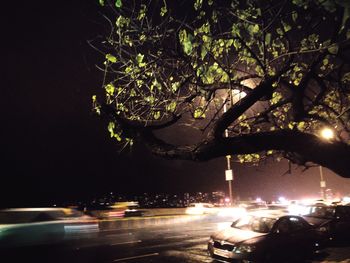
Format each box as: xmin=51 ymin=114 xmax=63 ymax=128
xmin=304 ymin=204 xmax=350 ymax=242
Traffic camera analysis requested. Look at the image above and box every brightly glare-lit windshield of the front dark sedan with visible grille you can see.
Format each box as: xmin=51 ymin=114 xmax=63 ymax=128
xmin=232 ymin=216 xmax=277 ymax=233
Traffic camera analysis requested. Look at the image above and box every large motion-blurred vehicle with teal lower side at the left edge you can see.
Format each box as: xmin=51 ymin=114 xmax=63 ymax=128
xmin=0 ymin=208 xmax=99 ymax=247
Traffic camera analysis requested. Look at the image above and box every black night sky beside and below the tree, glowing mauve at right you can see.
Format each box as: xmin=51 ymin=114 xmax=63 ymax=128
xmin=0 ymin=0 xmax=350 ymax=207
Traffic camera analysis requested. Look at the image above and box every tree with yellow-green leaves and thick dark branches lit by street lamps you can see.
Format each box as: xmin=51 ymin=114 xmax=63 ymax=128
xmin=91 ymin=0 xmax=350 ymax=177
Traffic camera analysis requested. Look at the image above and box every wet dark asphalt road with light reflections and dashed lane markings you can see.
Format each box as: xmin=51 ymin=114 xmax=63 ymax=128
xmin=0 ymin=216 xmax=350 ymax=263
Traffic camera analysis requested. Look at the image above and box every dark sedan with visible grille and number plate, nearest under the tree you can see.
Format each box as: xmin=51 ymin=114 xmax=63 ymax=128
xmin=208 ymin=211 xmax=323 ymax=262
